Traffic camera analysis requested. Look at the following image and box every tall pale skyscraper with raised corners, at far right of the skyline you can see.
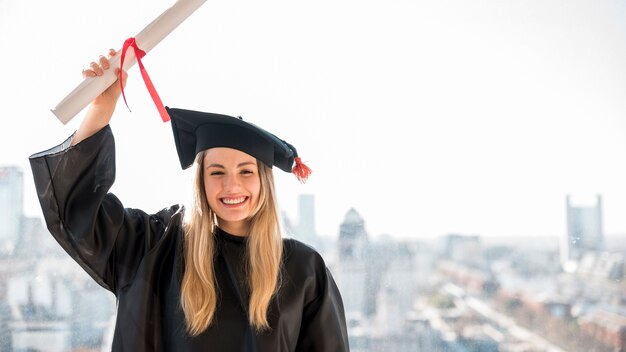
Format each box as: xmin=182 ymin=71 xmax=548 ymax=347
xmin=561 ymin=195 xmax=604 ymax=265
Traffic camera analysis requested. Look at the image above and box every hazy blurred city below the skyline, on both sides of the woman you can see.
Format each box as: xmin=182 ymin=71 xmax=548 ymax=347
xmin=0 ymin=167 xmax=626 ymax=352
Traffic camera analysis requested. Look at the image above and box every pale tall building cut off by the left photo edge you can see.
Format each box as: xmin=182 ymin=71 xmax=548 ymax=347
xmin=0 ymin=166 xmax=23 ymax=255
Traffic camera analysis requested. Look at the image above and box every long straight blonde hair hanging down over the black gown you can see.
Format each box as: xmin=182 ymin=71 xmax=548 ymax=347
xmin=180 ymin=152 xmax=283 ymax=336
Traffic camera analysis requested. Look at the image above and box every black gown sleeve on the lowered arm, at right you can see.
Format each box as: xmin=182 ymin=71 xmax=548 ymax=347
xmin=297 ymin=253 xmax=350 ymax=352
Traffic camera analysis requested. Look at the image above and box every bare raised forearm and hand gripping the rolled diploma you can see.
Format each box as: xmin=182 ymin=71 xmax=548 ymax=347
xmin=71 ymin=49 xmax=128 ymax=145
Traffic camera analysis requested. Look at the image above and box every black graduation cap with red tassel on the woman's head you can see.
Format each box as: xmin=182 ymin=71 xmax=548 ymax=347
xmin=165 ymin=107 xmax=311 ymax=182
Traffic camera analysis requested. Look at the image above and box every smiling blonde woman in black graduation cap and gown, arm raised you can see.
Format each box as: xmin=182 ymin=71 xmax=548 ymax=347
xmin=30 ymin=50 xmax=349 ymax=351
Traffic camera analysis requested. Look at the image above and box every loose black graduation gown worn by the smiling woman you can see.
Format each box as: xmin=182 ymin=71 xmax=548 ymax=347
xmin=30 ymin=126 xmax=349 ymax=352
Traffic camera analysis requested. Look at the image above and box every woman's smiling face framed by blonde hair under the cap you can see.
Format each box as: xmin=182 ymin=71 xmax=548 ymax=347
xmin=203 ymin=148 xmax=261 ymax=236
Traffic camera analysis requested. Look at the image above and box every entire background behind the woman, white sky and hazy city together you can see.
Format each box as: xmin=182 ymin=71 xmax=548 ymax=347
xmin=0 ymin=0 xmax=626 ymax=352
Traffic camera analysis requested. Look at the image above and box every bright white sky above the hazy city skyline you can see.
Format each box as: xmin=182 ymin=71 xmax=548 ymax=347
xmin=0 ymin=0 xmax=626 ymax=241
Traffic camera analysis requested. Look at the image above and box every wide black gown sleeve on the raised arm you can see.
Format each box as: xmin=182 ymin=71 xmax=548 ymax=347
xmin=29 ymin=126 xmax=164 ymax=296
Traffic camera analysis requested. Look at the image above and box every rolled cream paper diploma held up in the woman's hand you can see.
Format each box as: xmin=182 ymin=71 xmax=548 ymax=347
xmin=51 ymin=0 xmax=206 ymax=124
